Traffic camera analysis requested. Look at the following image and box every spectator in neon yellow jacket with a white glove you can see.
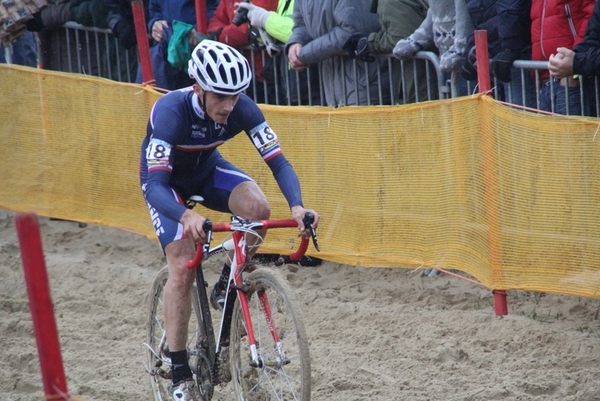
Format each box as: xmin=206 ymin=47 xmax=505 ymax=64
xmin=238 ymin=0 xmax=321 ymax=105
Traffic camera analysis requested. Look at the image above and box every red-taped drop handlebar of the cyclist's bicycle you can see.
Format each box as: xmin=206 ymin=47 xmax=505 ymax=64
xmin=185 ymin=212 xmax=320 ymax=269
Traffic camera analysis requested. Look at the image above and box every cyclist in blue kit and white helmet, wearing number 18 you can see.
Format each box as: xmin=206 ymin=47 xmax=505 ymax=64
xmin=140 ymin=40 xmax=319 ymax=401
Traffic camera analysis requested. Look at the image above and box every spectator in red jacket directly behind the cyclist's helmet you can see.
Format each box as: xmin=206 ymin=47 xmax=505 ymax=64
xmin=208 ymin=0 xmax=279 ymax=103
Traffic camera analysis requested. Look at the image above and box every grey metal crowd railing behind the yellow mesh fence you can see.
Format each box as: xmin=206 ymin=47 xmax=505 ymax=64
xmin=3 ymin=22 xmax=600 ymax=116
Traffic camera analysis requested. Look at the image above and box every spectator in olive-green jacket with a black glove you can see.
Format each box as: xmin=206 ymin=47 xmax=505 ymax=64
xmin=342 ymin=0 xmax=438 ymax=103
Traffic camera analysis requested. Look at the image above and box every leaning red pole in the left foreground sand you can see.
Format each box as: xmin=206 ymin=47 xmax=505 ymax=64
xmin=15 ymin=213 xmax=70 ymax=399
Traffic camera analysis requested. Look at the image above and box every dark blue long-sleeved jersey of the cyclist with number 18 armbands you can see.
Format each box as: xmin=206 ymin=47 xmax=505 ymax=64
xmin=140 ymin=87 xmax=302 ymax=220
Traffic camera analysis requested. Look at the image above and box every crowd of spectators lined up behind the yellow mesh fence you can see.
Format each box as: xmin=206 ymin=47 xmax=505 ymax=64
xmin=0 ymin=0 xmax=600 ymax=116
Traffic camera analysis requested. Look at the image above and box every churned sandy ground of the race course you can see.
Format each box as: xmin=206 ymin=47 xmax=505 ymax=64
xmin=0 ymin=210 xmax=600 ymax=401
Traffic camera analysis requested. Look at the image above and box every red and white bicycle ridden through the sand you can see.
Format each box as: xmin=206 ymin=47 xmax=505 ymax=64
xmin=145 ymin=197 xmax=319 ymax=401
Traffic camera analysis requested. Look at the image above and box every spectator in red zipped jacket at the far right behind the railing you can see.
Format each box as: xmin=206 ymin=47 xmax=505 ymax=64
xmin=531 ymin=0 xmax=595 ymax=115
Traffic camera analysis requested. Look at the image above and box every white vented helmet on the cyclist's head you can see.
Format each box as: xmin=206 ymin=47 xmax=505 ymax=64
xmin=188 ymin=39 xmax=252 ymax=95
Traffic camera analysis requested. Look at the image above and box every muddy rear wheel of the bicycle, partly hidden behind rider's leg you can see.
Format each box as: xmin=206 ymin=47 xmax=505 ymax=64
xmin=146 ymin=267 xmax=213 ymax=401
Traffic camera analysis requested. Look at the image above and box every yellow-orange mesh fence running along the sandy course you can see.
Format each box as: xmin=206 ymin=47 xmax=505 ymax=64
xmin=0 ymin=65 xmax=600 ymax=298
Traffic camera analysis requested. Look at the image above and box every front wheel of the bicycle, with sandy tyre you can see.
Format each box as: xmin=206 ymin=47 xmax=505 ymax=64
xmin=229 ymin=268 xmax=311 ymax=401
